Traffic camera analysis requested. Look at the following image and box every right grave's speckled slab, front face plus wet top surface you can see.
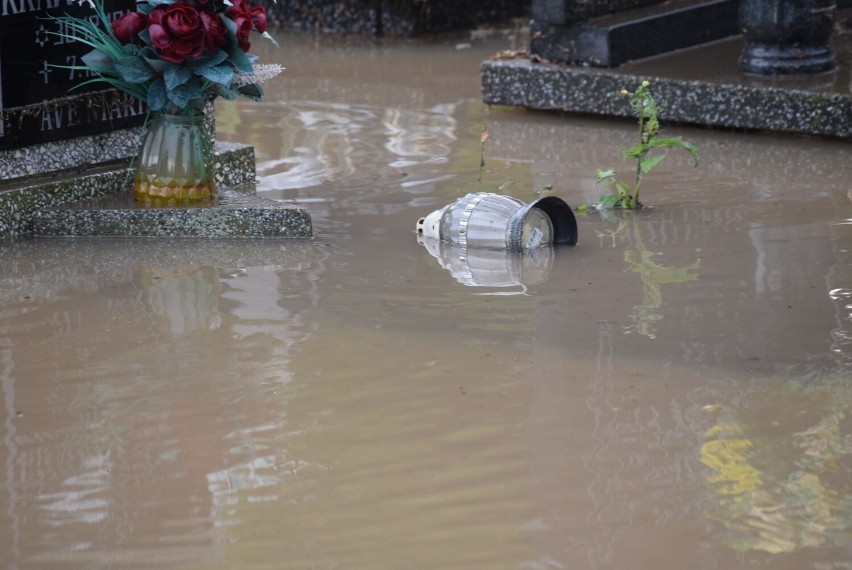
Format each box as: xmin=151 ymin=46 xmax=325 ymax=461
xmin=481 ymin=32 xmax=852 ymax=140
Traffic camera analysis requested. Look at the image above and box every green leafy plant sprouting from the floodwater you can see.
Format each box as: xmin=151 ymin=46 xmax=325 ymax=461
xmin=597 ymin=81 xmax=698 ymax=210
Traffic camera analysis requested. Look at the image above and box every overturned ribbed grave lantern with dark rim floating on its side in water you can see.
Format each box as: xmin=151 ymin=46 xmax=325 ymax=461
xmin=417 ymin=192 xmax=577 ymax=251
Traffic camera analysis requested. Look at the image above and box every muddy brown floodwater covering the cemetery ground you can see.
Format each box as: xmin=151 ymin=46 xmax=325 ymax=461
xmin=0 ymin=27 xmax=852 ymax=570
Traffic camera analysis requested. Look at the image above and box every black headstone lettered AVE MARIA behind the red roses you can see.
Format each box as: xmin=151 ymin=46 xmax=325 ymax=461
xmin=0 ymin=0 xmax=145 ymax=150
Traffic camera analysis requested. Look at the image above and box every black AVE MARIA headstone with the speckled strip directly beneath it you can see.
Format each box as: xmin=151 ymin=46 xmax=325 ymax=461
xmin=0 ymin=0 xmax=145 ymax=173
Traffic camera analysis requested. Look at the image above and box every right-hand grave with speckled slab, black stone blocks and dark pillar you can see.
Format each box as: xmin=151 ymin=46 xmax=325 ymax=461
xmin=480 ymin=0 xmax=852 ymax=140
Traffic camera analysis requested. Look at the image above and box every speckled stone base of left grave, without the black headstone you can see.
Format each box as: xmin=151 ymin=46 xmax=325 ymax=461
xmin=0 ymin=140 xmax=312 ymax=238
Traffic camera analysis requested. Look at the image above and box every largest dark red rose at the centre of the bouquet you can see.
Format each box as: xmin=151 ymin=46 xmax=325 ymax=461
xmin=148 ymin=1 xmax=204 ymax=63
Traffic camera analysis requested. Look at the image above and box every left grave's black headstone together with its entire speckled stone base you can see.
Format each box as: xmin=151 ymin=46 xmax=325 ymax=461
xmin=0 ymin=0 xmax=312 ymax=238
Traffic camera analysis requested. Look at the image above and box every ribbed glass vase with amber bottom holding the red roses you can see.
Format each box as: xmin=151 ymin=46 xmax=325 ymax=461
xmin=133 ymin=113 xmax=215 ymax=205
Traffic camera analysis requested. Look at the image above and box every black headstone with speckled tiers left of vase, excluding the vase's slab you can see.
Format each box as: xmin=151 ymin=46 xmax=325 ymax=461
xmin=0 ymin=0 xmax=150 ymax=237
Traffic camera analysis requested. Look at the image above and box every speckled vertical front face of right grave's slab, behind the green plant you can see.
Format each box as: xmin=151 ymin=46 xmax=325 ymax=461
xmin=481 ymin=59 xmax=852 ymax=140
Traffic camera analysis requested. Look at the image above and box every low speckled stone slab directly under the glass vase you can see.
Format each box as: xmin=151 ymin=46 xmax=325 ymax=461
xmin=32 ymin=188 xmax=313 ymax=238
